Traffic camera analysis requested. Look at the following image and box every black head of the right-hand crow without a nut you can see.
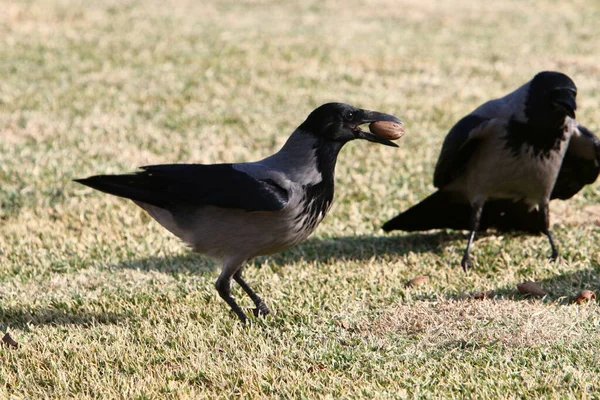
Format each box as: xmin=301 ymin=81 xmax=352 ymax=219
xmin=525 ymin=71 xmax=577 ymax=125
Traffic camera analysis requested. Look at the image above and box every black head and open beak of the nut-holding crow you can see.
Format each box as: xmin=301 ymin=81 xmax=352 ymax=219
xmin=298 ymin=103 xmax=402 ymax=147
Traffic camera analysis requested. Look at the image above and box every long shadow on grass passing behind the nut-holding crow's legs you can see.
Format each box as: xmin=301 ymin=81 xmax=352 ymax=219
xmin=115 ymin=231 xmax=465 ymax=274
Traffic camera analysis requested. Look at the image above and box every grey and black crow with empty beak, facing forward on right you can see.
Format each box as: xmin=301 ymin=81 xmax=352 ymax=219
xmin=383 ymin=72 xmax=600 ymax=271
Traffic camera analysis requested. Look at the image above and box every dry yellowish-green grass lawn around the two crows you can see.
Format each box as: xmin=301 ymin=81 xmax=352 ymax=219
xmin=0 ymin=0 xmax=600 ymax=399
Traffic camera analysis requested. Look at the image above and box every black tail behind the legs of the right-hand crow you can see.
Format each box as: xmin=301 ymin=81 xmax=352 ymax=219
xmin=382 ymin=190 xmax=544 ymax=233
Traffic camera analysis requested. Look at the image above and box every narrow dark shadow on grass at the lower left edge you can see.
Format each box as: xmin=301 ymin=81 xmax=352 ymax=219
xmin=0 ymin=306 xmax=127 ymax=332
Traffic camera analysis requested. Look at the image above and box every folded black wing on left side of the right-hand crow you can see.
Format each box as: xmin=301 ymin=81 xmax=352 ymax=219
xmin=433 ymin=114 xmax=493 ymax=189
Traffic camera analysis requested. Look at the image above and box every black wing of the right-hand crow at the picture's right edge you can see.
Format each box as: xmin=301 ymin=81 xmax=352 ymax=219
xmin=550 ymin=125 xmax=600 ymax=200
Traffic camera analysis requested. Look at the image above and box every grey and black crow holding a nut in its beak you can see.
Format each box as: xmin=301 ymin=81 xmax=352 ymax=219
xmin=76 ymin=103 xmax=401 ymax=322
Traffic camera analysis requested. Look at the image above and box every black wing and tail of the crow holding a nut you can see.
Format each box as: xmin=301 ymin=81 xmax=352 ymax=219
xmin=75 ymin=164 xmax=288 ymax=211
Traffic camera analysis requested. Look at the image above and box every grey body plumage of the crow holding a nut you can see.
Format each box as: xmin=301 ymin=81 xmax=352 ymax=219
xmin=138 ymin=131 xmax=332 ymax=263
